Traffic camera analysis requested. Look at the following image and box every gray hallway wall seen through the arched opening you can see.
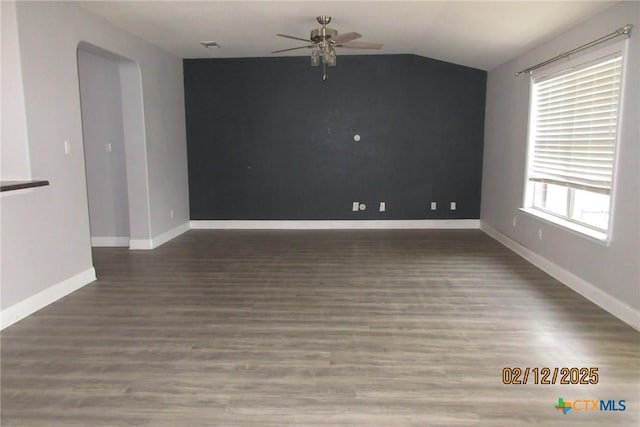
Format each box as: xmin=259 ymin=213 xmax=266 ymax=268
xmin=78 ymin=49 xmax=129 ymax=242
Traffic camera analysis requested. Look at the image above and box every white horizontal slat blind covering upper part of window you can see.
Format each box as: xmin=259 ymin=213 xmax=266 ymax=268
xmin=529 ymin=53 xmax=622 ymax=194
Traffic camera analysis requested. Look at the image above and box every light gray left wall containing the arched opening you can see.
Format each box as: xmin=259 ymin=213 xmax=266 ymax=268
xmin=0 ymin=2 xmax=189 ymax=326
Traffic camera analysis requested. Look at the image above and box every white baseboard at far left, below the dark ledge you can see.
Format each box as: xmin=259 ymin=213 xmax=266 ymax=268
xmin=0 ymin=267 xmax=96 ymax=329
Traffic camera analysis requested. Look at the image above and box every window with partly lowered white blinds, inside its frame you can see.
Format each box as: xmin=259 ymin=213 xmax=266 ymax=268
xmin=525 ymin=47 xmax=623 ymax=241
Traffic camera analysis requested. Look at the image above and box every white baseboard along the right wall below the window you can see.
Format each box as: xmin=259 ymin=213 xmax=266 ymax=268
xmin=480 ymin=223 xmax=640 ymax=331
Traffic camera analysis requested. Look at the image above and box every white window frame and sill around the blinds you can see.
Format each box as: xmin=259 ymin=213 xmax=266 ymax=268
xmin=522 ymin=40 xmax=628 ymax=244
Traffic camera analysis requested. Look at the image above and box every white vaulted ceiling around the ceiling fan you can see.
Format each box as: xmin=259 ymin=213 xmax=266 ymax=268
xmin=80 ymin=1 xmax=614 ymax=70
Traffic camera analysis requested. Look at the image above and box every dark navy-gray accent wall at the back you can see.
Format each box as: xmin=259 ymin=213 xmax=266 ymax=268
xmin=184 ymin=55 xmax=486 ymax=220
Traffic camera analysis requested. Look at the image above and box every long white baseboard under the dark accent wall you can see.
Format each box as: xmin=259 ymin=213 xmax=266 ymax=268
xmin=190 ymin=219 xmax=480 ymax=230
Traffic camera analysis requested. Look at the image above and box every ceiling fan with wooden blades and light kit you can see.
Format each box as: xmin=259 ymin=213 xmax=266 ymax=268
xmin=271 ymin=16 xmax=382 ymax=81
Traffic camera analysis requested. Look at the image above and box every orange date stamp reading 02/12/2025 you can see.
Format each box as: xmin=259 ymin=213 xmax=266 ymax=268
xmin=502 ymin=367 xmax=600 ymax=385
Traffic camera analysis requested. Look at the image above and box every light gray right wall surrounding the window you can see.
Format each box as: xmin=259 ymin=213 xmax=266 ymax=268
xmin=481 ymin=2 xmax=640 ymax=324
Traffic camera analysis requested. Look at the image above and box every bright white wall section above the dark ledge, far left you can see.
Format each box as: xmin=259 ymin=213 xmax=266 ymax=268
xmin=0 ymin=1 xmax=31 ymax=181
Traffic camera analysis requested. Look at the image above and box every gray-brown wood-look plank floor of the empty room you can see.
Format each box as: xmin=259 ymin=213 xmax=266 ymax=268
xmin=1 ymin=230 xmax=640 ymax=427
